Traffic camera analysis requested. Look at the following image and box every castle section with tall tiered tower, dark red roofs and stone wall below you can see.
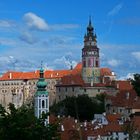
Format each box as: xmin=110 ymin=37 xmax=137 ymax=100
xmin=56 ymin=19 xmax=117 ymax=102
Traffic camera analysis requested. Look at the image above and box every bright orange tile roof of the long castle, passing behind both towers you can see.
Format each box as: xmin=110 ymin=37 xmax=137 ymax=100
xmin=0 ymin=63 xmax=114 ymax=81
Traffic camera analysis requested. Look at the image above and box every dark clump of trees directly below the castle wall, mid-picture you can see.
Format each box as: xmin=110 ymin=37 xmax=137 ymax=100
xmin=50 ymin=95 xmax=104 ymax=121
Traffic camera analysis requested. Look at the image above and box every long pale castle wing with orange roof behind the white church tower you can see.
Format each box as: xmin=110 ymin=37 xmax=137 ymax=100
xmin=0 ymin=70 xmax=71 ymax=108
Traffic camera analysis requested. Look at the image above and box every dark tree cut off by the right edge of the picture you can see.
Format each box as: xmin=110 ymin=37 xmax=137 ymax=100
xmin=131 ymin=73 xmax=140 ymax=96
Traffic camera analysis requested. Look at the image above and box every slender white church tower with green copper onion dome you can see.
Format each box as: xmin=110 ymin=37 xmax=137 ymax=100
xmin=35 ymin=67 xmax=49 ymax=123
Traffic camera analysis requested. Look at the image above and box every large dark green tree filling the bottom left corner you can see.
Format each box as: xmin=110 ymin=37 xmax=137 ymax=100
xmin=0 ymin=104 xmax=59 ymax=140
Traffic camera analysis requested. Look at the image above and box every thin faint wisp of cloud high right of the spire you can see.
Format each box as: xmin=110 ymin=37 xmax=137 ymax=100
xmin=108 ymin=3 xmax=123 ymax=16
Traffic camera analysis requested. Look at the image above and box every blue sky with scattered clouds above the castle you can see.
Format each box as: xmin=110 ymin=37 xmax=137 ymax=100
xmin=0 ymin=0 xmax=140 ymax=78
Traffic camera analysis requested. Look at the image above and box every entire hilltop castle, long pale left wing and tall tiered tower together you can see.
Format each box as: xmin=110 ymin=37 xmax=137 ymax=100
xmin=0 ymin=20 xmax=116 ymax=107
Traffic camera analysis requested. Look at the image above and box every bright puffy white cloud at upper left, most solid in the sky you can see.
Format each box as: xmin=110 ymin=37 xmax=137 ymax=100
xmin=23 ymin=12 xmax=49 ymax=31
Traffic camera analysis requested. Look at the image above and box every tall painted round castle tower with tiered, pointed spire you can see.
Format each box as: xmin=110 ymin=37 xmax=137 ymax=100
xmin=82 ymin=19 xmax=100 ymax=85
